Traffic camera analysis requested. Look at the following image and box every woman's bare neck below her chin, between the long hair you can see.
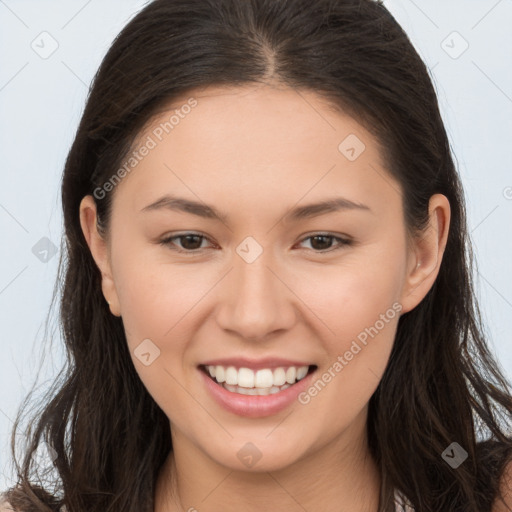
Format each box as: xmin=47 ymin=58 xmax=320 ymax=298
xmin=155 ymin=410 xmax=381 ymax=512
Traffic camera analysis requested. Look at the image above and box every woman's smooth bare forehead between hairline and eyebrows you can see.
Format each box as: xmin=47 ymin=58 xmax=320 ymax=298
xmin=111 ymin=85 xmax=398 ymax=218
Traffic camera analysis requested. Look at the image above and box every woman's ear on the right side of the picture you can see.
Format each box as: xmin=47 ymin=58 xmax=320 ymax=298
xmin=401 ymin=194 xmax=450 ymax=313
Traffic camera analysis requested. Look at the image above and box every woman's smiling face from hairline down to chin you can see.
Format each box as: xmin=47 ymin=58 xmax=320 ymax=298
xmin=81 ymin=86 xmax=444 ymax=471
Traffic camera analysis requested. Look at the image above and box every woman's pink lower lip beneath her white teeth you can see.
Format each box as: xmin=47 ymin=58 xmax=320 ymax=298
xmin=199 ymin=368 xmax=316 ymax=418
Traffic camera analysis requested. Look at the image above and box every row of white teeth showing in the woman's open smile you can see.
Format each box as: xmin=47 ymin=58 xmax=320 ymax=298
xmin=206 ymin=365 xmax=309 ymax=388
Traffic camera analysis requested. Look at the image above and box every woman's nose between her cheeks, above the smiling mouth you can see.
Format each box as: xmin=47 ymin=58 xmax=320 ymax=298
xmin=217 ymin=250 xmax=297 ymax=341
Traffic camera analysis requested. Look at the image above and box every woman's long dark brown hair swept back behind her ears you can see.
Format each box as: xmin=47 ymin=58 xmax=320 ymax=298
xmin=4 ymin=0 xmax=512 ymax=512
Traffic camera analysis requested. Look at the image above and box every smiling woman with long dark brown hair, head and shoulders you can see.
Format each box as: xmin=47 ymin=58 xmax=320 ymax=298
xmin=1 ymin=0 xmax=512 ymax=512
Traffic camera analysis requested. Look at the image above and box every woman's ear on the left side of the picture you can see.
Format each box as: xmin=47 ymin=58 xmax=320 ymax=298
xmin=80 ymin=195 xmax=121 ymax=316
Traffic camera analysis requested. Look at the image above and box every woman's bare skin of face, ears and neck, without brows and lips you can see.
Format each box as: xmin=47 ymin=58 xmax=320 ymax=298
xmin=80 ymin=85 xmax=450 ymax=512
